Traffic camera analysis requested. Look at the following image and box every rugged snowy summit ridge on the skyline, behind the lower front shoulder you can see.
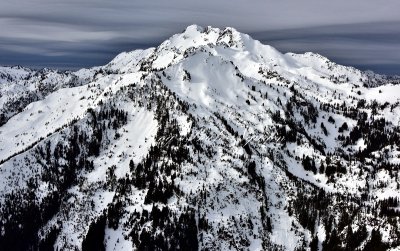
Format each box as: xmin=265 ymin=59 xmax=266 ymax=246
xmin=102 ymin=24 xmax=397 ymax=89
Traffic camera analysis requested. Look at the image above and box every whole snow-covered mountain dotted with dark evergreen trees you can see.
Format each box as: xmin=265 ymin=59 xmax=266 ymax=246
xmin=0 ymin=25 xmax=400 ymax=250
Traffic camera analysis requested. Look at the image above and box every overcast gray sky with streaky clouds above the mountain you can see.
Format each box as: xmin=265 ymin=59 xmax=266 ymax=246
xmin=0 ymin=0 xmax=400 ymax=75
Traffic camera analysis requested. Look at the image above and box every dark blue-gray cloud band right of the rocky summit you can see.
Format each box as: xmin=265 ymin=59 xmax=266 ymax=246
xmin=252 ymin=22 xmax=400 ymax=67
